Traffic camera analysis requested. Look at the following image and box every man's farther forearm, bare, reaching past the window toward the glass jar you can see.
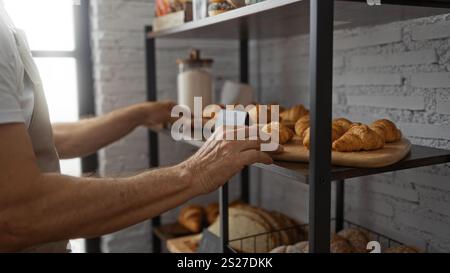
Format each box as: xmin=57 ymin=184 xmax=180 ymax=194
xmin=53 ymin=105 xmax=141 ymax=159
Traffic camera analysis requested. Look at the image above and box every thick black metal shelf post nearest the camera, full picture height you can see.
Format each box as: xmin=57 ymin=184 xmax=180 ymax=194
xmin=309 ymin=0 xmax=334 ymax=253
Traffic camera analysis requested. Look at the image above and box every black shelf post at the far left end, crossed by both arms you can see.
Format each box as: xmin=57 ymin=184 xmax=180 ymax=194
xmin=145 ymin=26 xmax=161 ymax=253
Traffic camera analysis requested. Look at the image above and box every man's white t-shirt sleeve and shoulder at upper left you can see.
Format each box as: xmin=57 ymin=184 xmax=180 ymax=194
xmin=0 ymin=0 xmax=34 ymax=128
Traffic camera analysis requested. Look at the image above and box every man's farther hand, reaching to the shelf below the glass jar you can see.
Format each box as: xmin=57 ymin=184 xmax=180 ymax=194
xmin=133 ymin=101 xmax=176 ymax=127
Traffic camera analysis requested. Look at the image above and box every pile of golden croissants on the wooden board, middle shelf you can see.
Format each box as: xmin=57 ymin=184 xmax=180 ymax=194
xmin=262 ymin=105 xmax=402 ymax=152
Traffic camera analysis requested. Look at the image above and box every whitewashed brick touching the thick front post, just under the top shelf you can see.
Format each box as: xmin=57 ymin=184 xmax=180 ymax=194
xmin=334 ymin=27 xmax=402 ymax=50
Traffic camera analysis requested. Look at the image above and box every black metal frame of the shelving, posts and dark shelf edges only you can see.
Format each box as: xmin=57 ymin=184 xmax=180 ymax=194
xmin=145 ymin=0 xmax=450 ymax=253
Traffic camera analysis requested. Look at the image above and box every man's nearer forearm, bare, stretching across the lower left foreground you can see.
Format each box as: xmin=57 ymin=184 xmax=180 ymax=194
xmin=0 ymin=165 xmax=195 ymax=251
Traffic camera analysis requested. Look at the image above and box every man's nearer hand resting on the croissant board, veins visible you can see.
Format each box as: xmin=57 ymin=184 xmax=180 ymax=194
xmin=180 ymin=128 xmax=281 ymax=194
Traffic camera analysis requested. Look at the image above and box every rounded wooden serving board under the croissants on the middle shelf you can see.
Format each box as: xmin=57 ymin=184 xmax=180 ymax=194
xmin=272 ymin=138 xmax=411 ymax=168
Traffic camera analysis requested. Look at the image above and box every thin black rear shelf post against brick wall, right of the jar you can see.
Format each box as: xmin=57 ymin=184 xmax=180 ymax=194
xmin=239 ymin=34 xmax=250 ymax=203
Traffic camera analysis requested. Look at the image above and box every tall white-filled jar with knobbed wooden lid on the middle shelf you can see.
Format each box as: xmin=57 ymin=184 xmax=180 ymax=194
xmin=177 ymin=49 xmax=214 ymax=111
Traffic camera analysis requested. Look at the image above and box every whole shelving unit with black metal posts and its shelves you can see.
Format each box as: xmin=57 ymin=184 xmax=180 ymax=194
xmin=146 ymin=0 xmax=450 ymax=252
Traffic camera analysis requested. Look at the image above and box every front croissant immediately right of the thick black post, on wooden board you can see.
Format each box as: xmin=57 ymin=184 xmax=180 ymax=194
xmin=333 ymin=125 xmax=384 ymax=152
